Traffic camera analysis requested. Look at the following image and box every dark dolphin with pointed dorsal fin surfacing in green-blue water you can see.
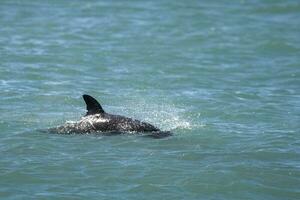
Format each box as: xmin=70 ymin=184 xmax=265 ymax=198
xmin=49 ymin=94 xmax=172 ymax=138
